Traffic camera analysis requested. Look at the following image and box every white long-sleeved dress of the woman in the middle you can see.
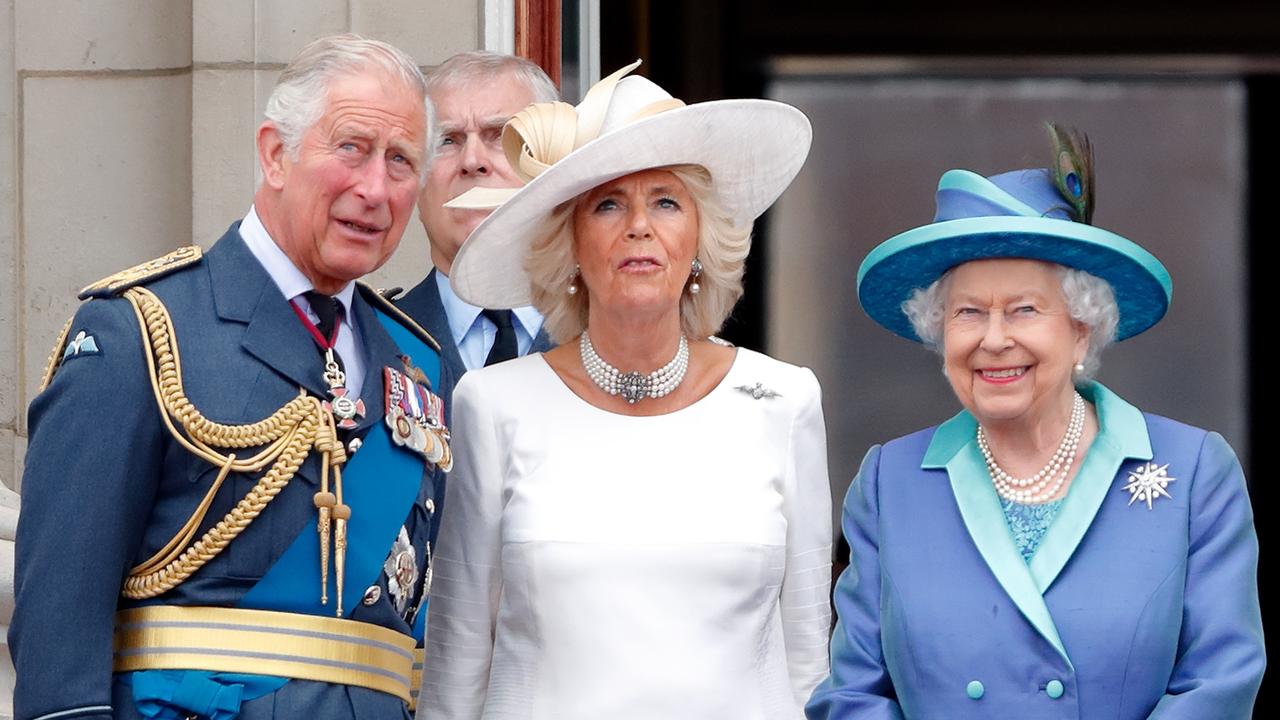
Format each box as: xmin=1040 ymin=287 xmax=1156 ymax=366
xmin=420 ymin=350 xmax=831 ymax=720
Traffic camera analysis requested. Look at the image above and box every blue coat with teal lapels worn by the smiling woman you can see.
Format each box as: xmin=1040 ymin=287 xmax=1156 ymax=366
xmin=806 ymin=383 xmax=1265 ymax=720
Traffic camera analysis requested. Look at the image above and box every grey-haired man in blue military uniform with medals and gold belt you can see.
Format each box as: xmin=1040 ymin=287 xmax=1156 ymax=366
xmin=9 ymin=36 xmax=451 ymax=720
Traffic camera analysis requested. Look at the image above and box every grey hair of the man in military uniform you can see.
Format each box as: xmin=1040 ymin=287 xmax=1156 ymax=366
xmin=265 ymin=32 xmax=426 ymax=159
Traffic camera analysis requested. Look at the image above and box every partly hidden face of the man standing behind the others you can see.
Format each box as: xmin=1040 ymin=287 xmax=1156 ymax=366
xmin=419 ymin=72 xmax=534 ymax=274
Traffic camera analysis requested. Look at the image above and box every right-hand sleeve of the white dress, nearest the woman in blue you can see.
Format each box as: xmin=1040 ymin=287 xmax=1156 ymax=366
xmin=781 ymin=369 xmax=832 ymax=706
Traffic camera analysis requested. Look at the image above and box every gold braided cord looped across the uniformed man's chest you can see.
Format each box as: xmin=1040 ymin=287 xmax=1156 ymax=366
xmin=122 ymin=287 xmax=347 ymax=600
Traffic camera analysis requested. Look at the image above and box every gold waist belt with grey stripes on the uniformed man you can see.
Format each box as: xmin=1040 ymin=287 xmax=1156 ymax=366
xmin=113 ymin=605 xmax=420 ymax=702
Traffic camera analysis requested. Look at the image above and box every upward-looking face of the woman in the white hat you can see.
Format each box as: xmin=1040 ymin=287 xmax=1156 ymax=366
xmin=573 ymin=169 xmax=698 ymax=315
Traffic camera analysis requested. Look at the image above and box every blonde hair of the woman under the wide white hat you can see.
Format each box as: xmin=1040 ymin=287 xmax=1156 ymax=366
xmin=525 ymin=165 xmax=751 ymax=343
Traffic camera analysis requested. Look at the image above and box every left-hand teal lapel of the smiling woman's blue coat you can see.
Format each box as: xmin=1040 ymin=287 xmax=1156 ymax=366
xmin=920 ymin=413 xmax=1071 ymax=665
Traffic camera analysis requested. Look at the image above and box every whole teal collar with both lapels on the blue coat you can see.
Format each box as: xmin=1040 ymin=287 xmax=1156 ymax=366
xmin=920 ymin=383 xmax=1152 ymax=664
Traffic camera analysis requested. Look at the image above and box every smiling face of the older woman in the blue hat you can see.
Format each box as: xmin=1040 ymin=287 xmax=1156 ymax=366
xmin=942 ymin=259 xmax=1088 ymax=428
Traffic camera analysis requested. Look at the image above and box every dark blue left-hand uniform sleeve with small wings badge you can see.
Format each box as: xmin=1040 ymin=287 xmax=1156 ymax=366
xmin=9 ymin=294 xmax=166 ymax=720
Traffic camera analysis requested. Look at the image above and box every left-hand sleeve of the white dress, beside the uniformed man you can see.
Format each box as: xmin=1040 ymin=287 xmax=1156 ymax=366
xmin=419 ymin=373 xmax=503 ymax=720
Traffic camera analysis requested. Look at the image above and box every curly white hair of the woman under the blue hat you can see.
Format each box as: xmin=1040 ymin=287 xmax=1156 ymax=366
xmin=902 ymin=264 xmax=1120 ymax=380
